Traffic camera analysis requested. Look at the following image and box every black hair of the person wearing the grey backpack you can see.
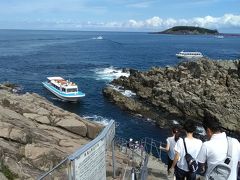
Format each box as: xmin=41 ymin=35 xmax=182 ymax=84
xmin=202 ymin=115 xmax=222 ymax=133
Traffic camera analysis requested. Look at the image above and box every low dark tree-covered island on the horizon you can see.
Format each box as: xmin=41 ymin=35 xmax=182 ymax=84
xmin=156 ymin=26 xmax=219 ymax=35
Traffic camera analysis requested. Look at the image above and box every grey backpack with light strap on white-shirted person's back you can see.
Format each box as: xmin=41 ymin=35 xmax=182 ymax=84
xmin=206 ymin=137 xmax=232 ymax=180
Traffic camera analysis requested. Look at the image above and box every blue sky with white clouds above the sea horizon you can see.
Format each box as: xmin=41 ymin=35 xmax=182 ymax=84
xmin=0 ymin=0 xmax=240 ymax=33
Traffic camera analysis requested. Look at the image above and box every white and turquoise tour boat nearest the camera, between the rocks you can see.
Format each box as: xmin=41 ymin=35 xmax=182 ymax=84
xmin=42 ymin=77 xmax=85 ymax=101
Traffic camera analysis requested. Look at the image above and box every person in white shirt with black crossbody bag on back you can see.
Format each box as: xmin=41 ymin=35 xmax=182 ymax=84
xmin=169 ymin=121 xmax=202 ymax=180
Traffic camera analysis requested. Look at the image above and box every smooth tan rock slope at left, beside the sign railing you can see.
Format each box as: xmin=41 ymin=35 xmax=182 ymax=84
xmin=0 ymin=85 xmax=102 ymax=179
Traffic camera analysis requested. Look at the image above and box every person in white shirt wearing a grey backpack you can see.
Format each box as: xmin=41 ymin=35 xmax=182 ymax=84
xmin=197 ymin=115 xmax=240 ymax=180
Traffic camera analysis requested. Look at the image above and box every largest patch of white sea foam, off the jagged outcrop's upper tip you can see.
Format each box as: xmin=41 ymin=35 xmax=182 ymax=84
xmin=95 ymin=66 xmax=130 ymax=81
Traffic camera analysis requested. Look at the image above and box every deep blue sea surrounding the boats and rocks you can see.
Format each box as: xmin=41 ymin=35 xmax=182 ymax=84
xmin=0 ymin=30 xmax=240 ymax=144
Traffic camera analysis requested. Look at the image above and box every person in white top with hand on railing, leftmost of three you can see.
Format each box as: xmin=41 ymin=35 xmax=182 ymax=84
xmin=160 ymin=126 xmax=180 ymax=174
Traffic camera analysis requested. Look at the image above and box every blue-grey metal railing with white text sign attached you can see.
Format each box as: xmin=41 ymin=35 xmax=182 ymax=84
xmin=38 ymin=121 xmax=115 ymax=180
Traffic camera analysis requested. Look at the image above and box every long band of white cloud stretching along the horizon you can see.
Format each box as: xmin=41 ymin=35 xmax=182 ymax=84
xmin=3 ymin=14 xmax=240 ymax=31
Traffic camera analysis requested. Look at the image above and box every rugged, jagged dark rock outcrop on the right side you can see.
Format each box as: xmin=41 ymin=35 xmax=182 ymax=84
xmin=103 ymin=58 xmax=240 ymax=133
